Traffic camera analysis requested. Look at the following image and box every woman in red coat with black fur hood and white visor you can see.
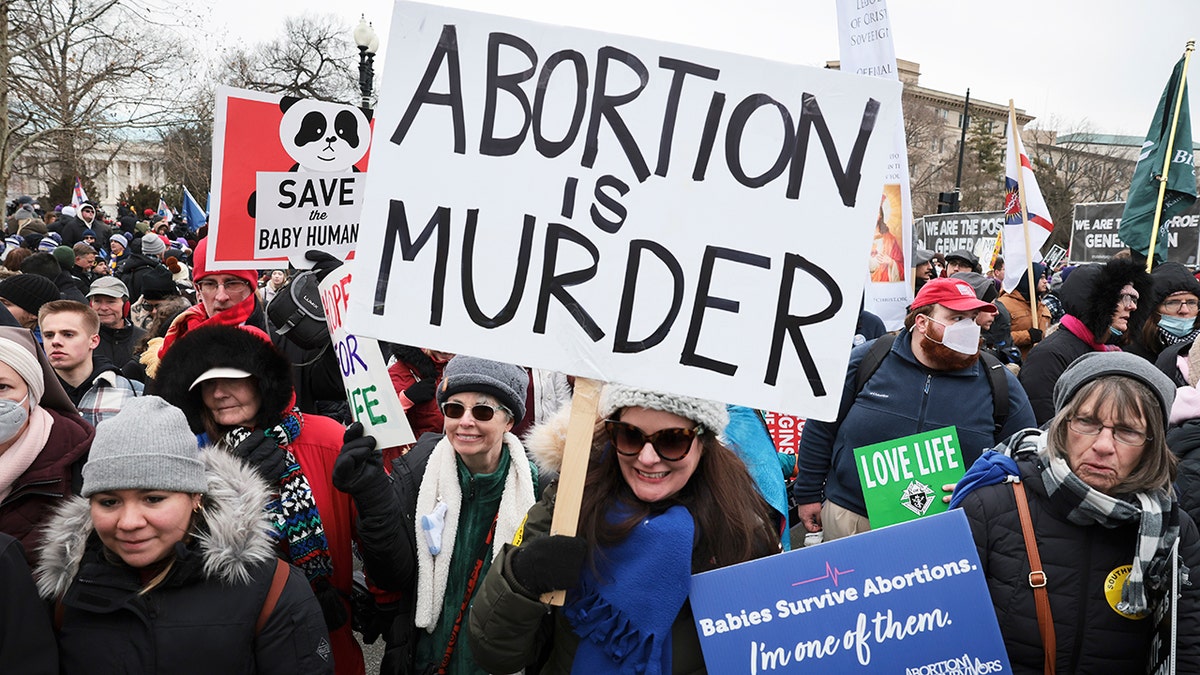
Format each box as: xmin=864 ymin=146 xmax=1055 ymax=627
xmin=151 ymin=323 xmax=364 ymax=674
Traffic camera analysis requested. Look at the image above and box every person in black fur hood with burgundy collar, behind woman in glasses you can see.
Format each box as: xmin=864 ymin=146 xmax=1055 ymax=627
xmin=1020 ymin=258 xmax=1154 ymax=424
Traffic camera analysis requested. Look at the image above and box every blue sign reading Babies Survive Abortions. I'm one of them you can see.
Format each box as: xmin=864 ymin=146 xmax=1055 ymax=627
xmin=691 ymin=509 xmax=1012 ymax=675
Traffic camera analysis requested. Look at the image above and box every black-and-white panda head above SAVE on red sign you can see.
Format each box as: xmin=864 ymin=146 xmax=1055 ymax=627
xmin=280 ymin=97 xmax=371 ymax=172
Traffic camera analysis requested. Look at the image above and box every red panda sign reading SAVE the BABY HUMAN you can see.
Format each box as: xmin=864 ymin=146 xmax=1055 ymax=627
xmin=206 ymin=86 xmax=371 ymax=270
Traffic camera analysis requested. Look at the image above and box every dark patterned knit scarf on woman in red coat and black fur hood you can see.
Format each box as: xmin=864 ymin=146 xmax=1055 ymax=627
xmin=223 ymin=410 xmax=334 ymax=584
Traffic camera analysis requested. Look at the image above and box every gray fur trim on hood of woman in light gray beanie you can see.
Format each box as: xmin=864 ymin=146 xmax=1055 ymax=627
xmin=36 ymin=448 xmax=275 ymax=598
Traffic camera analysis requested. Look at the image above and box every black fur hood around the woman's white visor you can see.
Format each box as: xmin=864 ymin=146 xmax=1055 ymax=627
xmin=148 ymin=325 xmax=295 ymax=434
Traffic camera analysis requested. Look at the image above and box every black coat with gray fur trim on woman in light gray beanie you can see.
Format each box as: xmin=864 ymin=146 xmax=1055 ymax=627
xmin=38 ymin=449 xmax=334 ymax=675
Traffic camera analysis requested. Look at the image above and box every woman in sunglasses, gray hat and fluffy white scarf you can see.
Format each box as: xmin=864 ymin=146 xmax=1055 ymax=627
xmin=334 ymin=354 xmax=538 ymax=675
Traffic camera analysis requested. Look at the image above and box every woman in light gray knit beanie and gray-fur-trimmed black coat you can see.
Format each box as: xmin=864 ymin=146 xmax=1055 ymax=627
xmin=37 ymin=396 xmax=332 ymax=674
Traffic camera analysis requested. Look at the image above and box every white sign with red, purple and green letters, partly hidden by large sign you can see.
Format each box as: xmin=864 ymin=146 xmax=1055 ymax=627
xmin=319 ymin=267 xmax=416 ymax=448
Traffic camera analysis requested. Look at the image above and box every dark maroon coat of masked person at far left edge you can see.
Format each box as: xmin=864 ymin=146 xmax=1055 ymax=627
xmin=0 ymin=408 xmax=96 ymax=560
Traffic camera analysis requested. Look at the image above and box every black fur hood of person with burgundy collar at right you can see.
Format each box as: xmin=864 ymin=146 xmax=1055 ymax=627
xmin=1058 ymin=258 xmax=1156 ymax=341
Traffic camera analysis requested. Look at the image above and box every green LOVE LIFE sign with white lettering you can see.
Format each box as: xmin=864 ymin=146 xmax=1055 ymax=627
xmin=854 ymin=426 xmax=966 ymax=527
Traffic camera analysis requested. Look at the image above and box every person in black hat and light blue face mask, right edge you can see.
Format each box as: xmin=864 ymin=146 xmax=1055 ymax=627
xmin=1126 ymin=263 xmax=1200 ymax=362
